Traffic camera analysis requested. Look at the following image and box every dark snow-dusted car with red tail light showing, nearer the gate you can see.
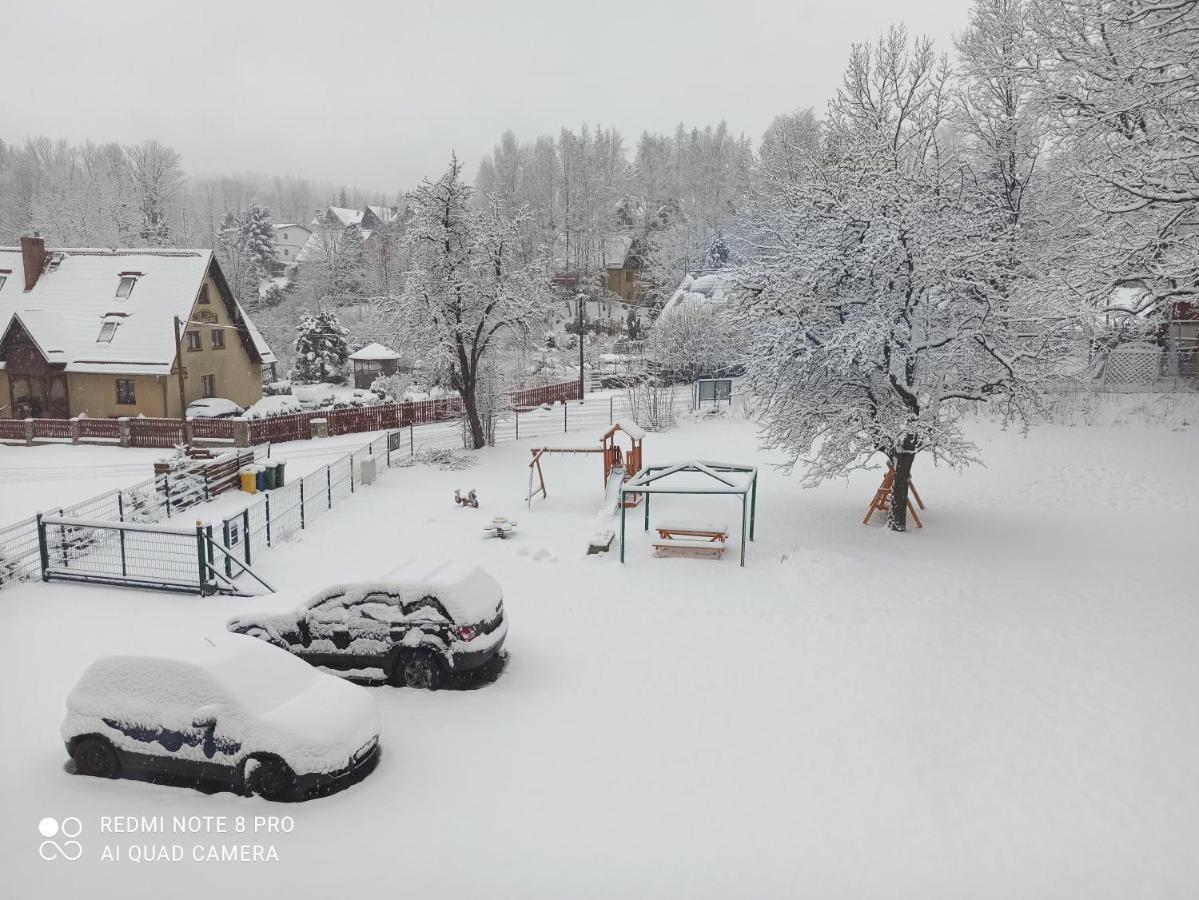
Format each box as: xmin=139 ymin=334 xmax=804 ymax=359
xmin=229 ymin=562 xmax=508 ymax=690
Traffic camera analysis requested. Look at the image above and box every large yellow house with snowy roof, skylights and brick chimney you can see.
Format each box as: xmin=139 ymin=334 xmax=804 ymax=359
xmin=0 ymin=236 xmax=275 ymax=418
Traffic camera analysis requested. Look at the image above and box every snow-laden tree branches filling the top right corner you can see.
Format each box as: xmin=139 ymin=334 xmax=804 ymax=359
xmin=1028 ymin=0 xmax=1199 ymax=316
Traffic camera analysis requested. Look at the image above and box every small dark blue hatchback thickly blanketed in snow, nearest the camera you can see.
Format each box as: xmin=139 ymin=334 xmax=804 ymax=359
xmin=62 ymin=634 xmax=379 ymax=799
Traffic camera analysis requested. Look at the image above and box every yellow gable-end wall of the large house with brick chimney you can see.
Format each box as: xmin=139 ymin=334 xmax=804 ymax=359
xmin=167 ymin=278 xmax=263 ymax=417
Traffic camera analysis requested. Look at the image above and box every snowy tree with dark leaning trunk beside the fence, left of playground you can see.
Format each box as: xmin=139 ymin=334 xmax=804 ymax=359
xmin=397 ymin=157 xmax=552 ymax=447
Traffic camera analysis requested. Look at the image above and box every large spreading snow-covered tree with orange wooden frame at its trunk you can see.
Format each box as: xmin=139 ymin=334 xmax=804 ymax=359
xmin=739 ymin=30 xmax=1074 ymax=531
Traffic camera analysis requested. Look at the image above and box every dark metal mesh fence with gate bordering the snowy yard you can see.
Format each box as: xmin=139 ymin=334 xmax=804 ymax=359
xmin=0 ymin=392 xmax=689 ymax=593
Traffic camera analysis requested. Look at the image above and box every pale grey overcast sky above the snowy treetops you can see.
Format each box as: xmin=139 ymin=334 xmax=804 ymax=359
xmin=0 ymin=0 xmax=968 ymax=192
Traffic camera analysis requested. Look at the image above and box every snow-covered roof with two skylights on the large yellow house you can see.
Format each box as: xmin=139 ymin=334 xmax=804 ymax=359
xmin=0 ymin=247 xmax=273 ymax=375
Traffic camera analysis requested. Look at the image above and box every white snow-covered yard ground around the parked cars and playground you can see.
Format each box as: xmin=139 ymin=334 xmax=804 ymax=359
xmin=0 ymin=409 xmax=1199 ymax=900
